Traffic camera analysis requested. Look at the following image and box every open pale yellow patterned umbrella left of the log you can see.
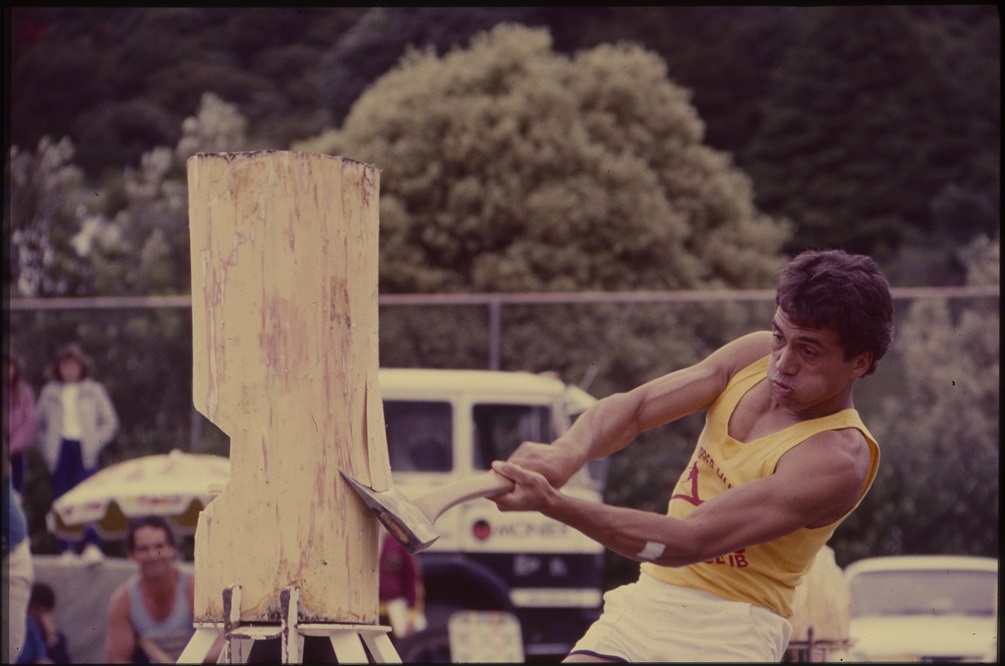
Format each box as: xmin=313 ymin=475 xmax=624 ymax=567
xmin=46 ymin=449 xmax=230 ymax=539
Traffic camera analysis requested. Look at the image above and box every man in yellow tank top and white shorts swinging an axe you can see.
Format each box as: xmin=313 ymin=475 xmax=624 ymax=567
xmin=492 ymin=250 xmax=893 ymax=662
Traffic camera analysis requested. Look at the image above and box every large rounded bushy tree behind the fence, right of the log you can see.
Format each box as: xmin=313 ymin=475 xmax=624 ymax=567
xmin=294 ymin=24 xmax=788 ymax=594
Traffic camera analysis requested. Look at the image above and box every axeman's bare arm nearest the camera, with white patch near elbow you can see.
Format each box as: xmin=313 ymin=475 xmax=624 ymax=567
xmin=492 ymin=430 xmax=869 ymax=567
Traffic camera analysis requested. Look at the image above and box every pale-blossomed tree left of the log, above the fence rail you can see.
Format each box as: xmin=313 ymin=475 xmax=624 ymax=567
xmin=4 ymin=93 xmax=248 ymax=296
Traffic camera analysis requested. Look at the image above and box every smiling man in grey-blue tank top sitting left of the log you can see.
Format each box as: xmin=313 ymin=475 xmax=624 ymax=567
xmin=105 ymin=515 xmax=220 ymax=664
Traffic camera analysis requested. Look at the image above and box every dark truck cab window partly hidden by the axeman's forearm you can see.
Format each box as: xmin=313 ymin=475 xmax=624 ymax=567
xmin=471 ymin=404 xmax=558 ymax=469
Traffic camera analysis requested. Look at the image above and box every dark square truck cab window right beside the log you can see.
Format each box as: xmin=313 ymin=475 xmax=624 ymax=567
xmin=384 ymin=400 xmax=453 ymax=472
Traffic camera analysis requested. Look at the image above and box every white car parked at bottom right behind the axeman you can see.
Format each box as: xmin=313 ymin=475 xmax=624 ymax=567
xmin=832 ymin=556 xmax=998 ymax=662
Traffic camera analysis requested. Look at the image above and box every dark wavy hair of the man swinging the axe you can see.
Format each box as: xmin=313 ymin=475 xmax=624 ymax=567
xmin=775 ymin=250 xmax=893 ymax=375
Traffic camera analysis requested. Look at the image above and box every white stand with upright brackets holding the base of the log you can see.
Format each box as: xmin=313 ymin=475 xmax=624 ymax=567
xmin=178 ymin=586 xmax=401 ymax=664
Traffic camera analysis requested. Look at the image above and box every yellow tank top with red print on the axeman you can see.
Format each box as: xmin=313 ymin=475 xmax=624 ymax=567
xmin=641 ymin=357 xmax=879 ymax=618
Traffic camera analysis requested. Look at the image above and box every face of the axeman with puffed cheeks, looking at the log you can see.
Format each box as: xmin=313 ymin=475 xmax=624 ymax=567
xmin=768 ymin=307 xmax=870 ymax=418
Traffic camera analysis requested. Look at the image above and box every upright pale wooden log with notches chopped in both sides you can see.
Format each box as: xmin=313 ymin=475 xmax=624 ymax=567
xmin=188 ymin=152 xmax=391 ymax=624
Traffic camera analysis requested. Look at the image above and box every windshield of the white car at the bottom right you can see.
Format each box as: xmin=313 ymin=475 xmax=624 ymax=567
xmin=850 ymin=569 xmax=998 ymax=617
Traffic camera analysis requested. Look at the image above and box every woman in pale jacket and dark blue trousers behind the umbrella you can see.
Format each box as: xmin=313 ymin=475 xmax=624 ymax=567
xmin=37 ymin=343 xmax=119 ymax=558
